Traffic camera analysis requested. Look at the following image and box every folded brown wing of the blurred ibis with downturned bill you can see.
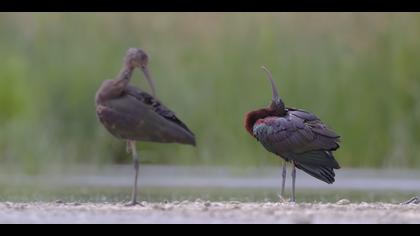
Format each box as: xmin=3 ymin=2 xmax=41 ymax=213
xmin=97 ymin=86 xmax=195 ymax=145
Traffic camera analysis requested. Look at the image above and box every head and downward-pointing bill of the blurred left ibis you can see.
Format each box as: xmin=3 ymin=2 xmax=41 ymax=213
xmin=124 ymin=48 xmax=155 ymax=96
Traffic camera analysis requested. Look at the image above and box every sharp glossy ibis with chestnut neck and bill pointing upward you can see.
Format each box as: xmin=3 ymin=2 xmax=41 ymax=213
xmin=245 ymin=67 xmax=340 ymax=202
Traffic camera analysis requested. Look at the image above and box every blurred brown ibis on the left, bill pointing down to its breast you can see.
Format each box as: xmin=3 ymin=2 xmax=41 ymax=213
xmin=95 ymin=48 xmax=195 ymax=205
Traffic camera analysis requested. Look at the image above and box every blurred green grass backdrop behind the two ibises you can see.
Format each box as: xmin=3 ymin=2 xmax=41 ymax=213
xmin=0 ymin=13 xmax=420 ymax=172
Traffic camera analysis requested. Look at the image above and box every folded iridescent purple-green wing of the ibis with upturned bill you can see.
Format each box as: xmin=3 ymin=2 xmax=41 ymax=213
xmin=254 ymin=111 xmax=339 ymax=167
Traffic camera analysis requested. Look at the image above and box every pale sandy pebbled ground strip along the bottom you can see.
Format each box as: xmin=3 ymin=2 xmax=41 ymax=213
xmin=0 ymin=200 xmax=420 ymax=224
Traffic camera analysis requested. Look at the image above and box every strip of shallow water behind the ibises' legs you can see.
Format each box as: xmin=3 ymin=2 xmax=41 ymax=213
xmin=0 ymin=166 xmax=420 ymax=203
